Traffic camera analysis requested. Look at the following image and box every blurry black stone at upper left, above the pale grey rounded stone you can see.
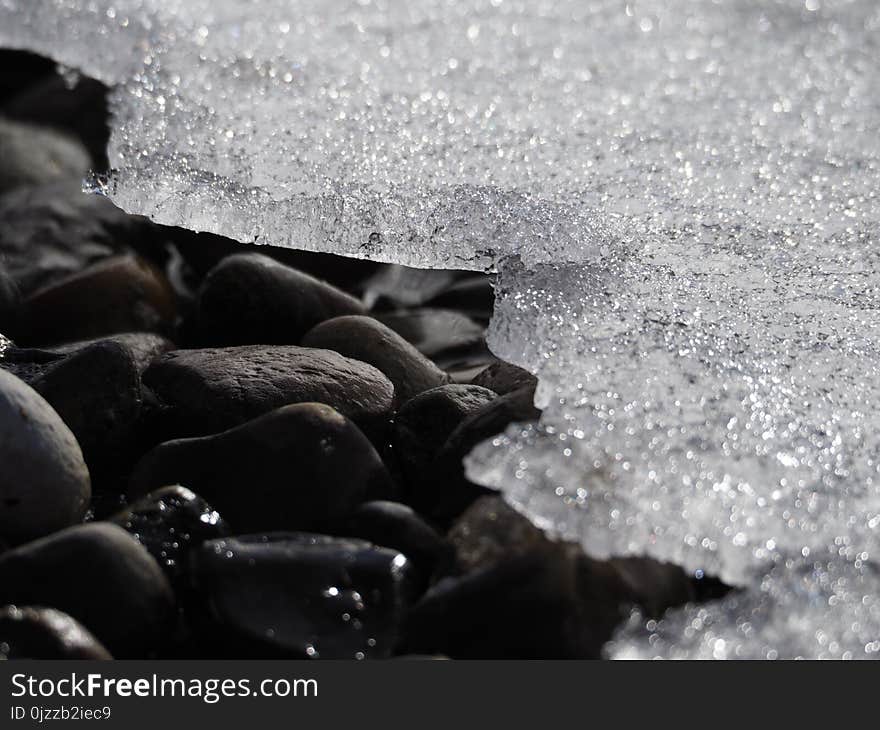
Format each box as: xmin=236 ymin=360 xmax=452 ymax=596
xmin=3 ymin=73 xmax=110 ymax=170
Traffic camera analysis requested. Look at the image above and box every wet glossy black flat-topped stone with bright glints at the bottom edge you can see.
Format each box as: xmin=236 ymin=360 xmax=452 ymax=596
xmin=191 ymin=533 xmax=409 ymax=659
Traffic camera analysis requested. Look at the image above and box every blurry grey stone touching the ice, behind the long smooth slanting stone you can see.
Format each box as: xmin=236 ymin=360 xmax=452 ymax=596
xmin=375 ymin=308 xmax=492 ymax=370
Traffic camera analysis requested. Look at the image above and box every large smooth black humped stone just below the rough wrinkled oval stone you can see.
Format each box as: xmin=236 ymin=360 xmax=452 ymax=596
xmin=130 ymin=403 xmax=392 ymax=532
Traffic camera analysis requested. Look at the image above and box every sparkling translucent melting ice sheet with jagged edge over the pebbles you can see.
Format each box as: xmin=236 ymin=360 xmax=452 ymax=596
xmin=0 ymin=0 xmax=880 ymax=658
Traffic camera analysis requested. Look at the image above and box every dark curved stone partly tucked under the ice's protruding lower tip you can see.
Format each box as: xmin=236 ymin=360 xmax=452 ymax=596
xmin=408 ymin=389 xmax=541 ymax=524
